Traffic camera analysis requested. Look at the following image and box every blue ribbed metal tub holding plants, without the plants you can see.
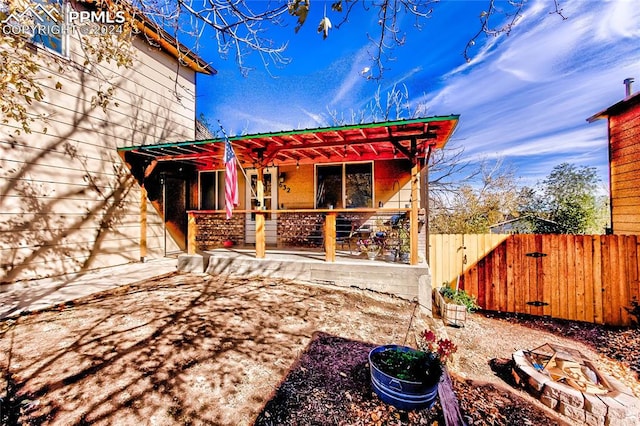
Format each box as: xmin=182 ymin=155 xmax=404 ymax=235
xmin=369 ymin=345 xmax=438 ymax=411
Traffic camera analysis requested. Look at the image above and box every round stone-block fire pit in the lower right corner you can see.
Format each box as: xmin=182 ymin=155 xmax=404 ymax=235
xmin=513 ymin=344 xmax=640 ymax=426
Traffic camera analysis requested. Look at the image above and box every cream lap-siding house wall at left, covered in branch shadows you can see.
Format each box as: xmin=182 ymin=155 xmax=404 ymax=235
xmin=0 ymin=30 xmax=200 ymax=282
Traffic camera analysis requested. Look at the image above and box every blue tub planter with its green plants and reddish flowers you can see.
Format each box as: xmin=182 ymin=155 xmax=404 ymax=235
xmin=369 ymin=330 xmax=457 ymax=410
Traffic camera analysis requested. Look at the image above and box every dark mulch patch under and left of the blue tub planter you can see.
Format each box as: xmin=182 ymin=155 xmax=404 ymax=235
xmin=256 ymin=333 xmax=436 ymax=425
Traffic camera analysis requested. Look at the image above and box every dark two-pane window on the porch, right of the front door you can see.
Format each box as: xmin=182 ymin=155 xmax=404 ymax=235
xmin=316 ymin=162 xmax=373 ymax=209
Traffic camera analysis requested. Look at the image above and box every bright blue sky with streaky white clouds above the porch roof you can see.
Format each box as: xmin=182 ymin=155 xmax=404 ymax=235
xmin=197 ymin=0 xmax=640 ymax=185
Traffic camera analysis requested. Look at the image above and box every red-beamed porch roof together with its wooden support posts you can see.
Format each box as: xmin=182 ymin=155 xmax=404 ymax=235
xmin=119 ymin=115 xmax=459 ymax=264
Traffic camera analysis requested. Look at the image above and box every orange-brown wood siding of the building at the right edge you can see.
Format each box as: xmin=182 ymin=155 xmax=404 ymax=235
xmin=609 ymin=102 xmax=640 ymax=234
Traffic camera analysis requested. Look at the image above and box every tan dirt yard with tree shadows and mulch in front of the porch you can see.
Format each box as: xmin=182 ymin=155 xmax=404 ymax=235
xmin=0 ymin=273 xmax=640 ymax=425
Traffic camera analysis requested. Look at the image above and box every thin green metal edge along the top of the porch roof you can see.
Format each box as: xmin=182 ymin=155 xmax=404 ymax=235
xmin=118 ymin=114 xmax=460 ymax=152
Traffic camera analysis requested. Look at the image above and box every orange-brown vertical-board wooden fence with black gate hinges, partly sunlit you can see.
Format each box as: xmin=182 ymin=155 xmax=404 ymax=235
xmin=430 ymin=234 xmax=640 ymax=325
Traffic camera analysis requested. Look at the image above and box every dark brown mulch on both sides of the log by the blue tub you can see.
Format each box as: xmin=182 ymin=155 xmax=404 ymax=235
xmin=255 ymin=333 xmax=567 ymax=426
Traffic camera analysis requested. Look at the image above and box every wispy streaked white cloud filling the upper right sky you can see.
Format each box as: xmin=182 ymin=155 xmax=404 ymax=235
xmin=427 ymin=1 xmax=640 ymax=184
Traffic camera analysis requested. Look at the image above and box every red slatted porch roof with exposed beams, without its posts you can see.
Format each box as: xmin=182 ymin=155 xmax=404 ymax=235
xmin=119 ymin=115 xmax=459 ymax=170
